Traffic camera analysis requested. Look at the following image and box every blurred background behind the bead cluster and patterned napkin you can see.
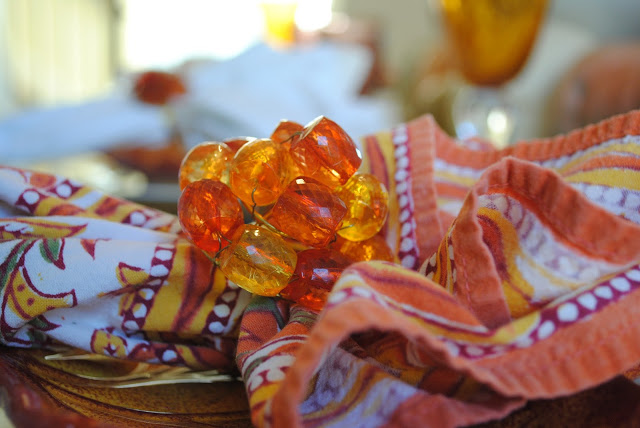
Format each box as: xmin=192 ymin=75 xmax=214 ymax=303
xmin=0 ymin=0 xmax=640 ymax=211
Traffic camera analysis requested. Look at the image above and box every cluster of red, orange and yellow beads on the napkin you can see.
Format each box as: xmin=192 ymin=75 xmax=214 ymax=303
xmin=178 ymin=116 xmax=393 ymax=310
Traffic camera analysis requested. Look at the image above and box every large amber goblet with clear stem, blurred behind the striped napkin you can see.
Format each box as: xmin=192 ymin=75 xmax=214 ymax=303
xmin=439 ymin=0 xmax=548 ymax=148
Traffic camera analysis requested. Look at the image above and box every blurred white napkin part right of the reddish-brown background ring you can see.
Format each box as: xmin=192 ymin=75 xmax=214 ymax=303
xmin=174 ymin=42 xmax=399 ymax=146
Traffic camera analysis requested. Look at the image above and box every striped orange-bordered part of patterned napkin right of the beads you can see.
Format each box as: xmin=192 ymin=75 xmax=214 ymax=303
xmin=237 ymin=112 xmax=640 ymax=427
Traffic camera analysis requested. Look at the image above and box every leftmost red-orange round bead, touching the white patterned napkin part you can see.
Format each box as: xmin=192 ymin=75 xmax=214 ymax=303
xmin=178 ymin=179 xmax=244 ymax=253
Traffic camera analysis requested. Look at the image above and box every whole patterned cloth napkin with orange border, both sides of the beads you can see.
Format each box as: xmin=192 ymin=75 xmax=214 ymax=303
xmin=0 ymin=111 xmax=640 ymax=427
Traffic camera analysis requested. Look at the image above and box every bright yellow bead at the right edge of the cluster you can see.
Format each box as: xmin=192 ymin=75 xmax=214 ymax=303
xmin=336 ymin=173 xmax=389 ymax=241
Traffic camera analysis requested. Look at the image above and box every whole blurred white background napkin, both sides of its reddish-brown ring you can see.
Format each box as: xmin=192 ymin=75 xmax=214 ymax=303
xmin=0 ymin=42 xmax=399 ymax=166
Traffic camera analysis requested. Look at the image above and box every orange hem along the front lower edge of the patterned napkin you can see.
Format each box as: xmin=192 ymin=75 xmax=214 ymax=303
xmin=272 ymin=280 xmax=640 ymax=426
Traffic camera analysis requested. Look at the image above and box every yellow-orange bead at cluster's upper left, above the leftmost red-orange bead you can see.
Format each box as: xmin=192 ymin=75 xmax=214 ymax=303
xmin=178 ymin=141 xmax=233 ymax=190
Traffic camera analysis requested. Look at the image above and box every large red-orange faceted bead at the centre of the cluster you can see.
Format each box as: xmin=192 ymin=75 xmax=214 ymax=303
xmin=268 ymin=177 xmax=347 ymax=247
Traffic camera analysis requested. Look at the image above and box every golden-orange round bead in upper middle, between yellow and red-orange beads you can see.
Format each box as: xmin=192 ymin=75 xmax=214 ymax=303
xmin=229 ymin=138 xmax=293 ymax=207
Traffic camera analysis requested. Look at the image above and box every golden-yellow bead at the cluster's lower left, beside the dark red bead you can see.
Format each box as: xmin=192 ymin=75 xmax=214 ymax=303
xmin=218 ymin=224 xmax=297 ymax=296
